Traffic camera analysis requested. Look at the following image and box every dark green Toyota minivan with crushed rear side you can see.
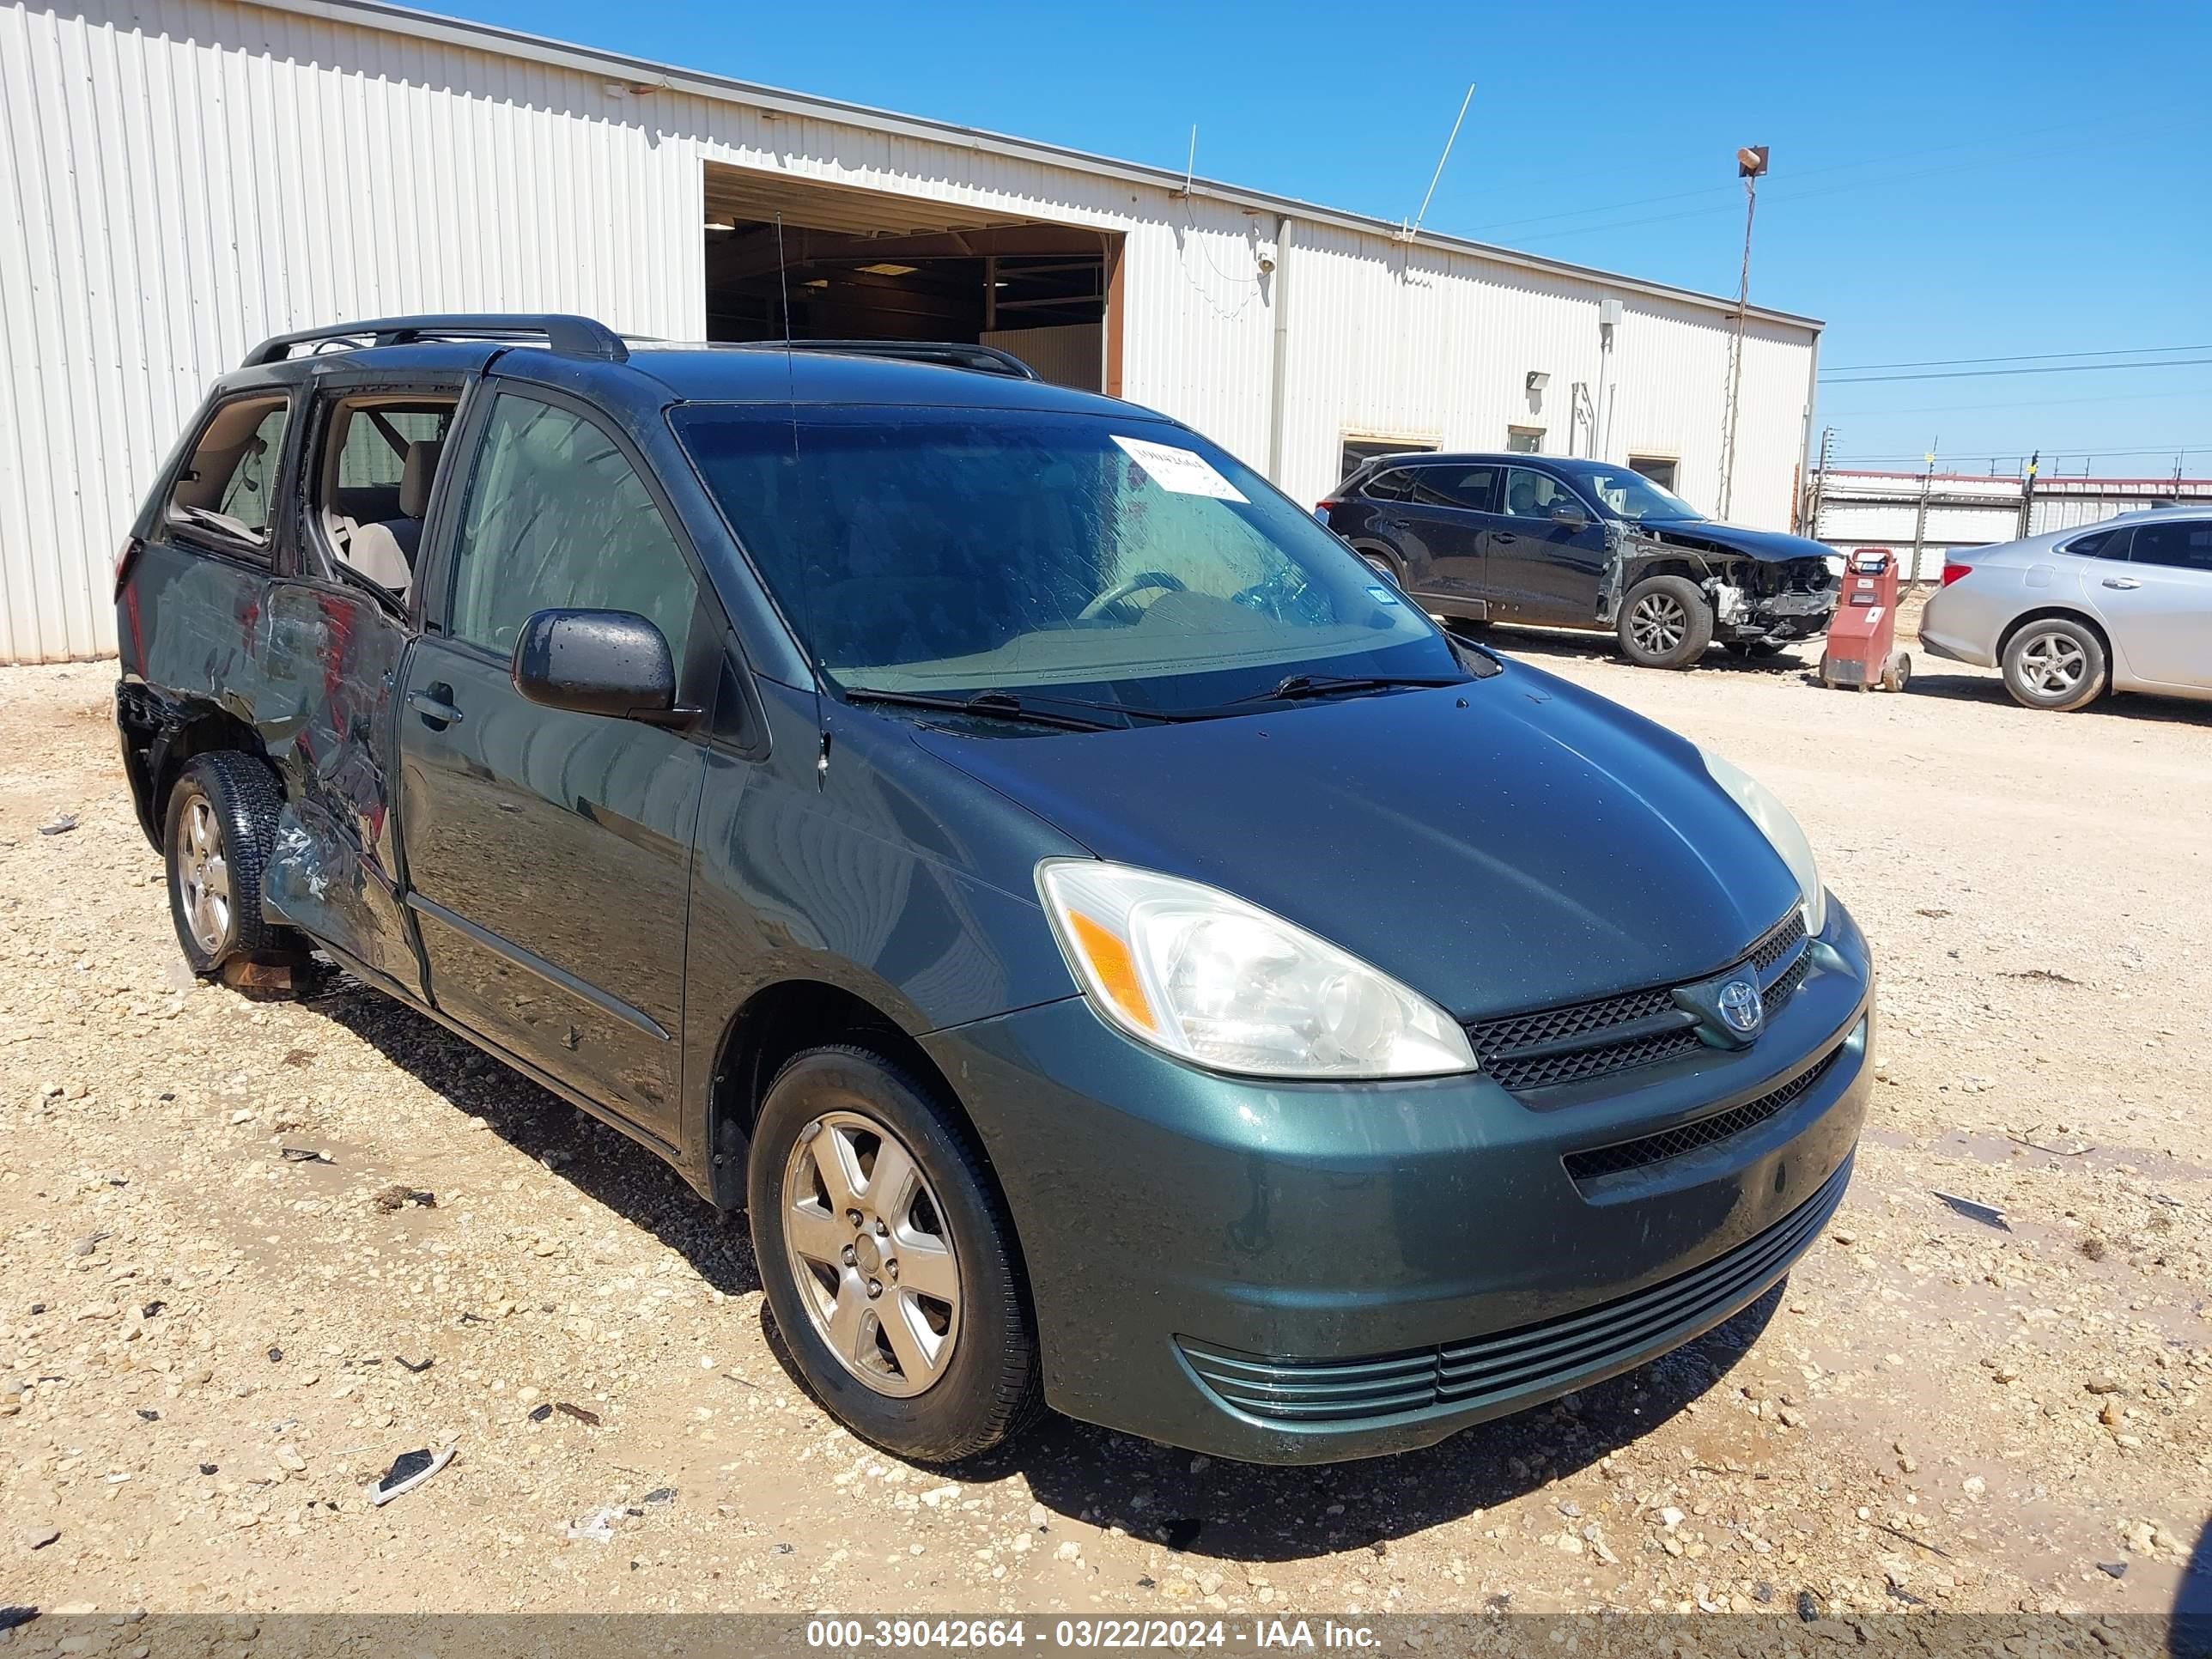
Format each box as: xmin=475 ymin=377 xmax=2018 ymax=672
xmin=118 ymin=316 xmax=1874 ymax=1462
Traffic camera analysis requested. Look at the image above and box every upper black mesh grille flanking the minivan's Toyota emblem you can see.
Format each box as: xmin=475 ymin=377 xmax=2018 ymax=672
xmin=1467 ymin=909 xmax=1812 ymax=1093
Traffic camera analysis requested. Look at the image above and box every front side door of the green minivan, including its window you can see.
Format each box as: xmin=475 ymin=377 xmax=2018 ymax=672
xmin=398 ymin=392 xmax=719 ymax=1144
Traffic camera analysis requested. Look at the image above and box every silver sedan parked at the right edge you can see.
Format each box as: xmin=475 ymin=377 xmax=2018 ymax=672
xmin=1920 ymin=508 xmax=2212 ymax=710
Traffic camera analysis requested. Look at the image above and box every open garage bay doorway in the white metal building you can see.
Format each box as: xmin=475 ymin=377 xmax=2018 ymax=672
xmin=703 ymin=161 xmax=1121 ymax=392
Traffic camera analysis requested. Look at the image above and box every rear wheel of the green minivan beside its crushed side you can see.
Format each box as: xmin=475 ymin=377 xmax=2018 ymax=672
xmin=164 ymin=750 xmax=299 ymax=975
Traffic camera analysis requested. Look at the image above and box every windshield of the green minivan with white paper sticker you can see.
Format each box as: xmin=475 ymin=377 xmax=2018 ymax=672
xmin=672 ymin=404 xmax=1467 ymax=712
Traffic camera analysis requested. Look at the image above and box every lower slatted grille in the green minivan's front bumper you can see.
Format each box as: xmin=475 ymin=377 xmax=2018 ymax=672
xmin=1176 ymin=1159 xmax=1851 ymax=1425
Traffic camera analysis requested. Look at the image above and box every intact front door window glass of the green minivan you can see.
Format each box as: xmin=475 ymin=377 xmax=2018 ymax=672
xmin=447 ymin=392 xmax=699 ymax=668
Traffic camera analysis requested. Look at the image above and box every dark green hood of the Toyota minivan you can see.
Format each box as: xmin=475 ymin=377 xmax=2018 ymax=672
xmin=915 ymin=664 xmax=1798 ymax=1020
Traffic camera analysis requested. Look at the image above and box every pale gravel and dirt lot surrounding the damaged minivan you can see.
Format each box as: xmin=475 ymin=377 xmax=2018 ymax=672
xmin=0 ymin=637 xmax=2212 ymax=1613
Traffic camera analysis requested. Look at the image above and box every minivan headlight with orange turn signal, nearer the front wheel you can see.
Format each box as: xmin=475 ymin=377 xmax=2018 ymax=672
xmin=1037 ymin=858 xmax=1475 ymax=1079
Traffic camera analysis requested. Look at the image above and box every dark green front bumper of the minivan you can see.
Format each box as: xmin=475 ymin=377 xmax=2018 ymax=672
xmin=925 ymin=898 xmax=1874 ymax=1462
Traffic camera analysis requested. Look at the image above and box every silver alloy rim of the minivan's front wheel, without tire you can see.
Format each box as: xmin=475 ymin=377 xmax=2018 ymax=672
xmin=783 ymin=1113 xmax=960 ymax=1395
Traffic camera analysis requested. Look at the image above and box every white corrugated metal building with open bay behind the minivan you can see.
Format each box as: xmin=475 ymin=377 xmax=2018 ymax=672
xmin=0 ymin=0 xmax=1820 ymax=661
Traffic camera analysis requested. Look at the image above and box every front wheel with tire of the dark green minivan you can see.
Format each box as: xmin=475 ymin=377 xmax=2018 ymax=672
xmin=745 ymin=1046 xmax=1040 ymax=1462
